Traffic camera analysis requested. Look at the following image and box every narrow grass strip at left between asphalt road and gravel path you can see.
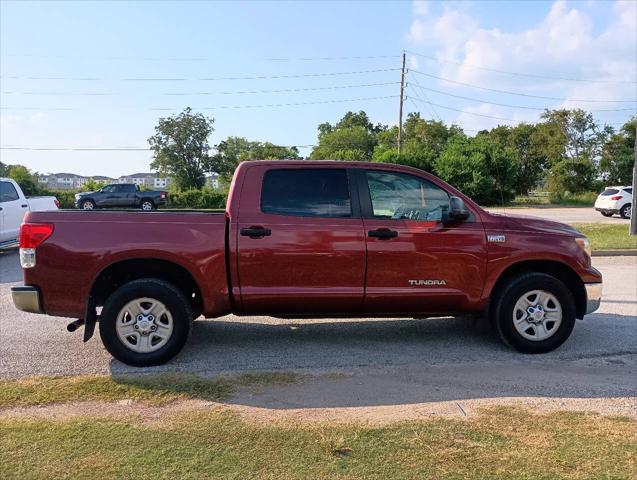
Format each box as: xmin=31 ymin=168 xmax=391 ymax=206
xmin=0 ymin=372 xmax=302 ymax=408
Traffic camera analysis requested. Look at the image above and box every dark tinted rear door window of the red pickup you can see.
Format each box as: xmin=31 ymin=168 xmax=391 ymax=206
xmin=261 ymin=168 xmax=352 ymax=217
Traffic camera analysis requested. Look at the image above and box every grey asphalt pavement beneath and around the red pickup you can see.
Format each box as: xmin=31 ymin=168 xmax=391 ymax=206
xmin=0 ymin=254 xmax=637 ymax=408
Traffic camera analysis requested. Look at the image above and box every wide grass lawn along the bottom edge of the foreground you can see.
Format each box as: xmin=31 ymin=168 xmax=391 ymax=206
xmin=0 ymin=408 xmax=637 ymax=480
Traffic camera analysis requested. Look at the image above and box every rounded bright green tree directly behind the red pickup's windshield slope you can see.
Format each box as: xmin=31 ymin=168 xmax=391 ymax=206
xmin=435 ymin=134 xmax=518 ymax=205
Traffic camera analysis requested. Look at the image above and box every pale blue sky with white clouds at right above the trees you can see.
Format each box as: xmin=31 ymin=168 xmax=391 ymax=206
xmin=0 ymin=1 xmax=637 ymax=176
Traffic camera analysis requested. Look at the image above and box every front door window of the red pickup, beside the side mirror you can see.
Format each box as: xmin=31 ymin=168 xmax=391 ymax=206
xmin=367 ymin=170 xmax=449 ymax=221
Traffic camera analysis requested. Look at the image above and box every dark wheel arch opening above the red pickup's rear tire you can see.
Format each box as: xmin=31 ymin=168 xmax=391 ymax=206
xmin=90 ymin=257 xmax=203 ymax=316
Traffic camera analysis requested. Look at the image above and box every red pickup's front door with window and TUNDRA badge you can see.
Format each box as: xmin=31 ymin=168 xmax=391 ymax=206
xmin=357 ymin=169 xmax=486 ymax=314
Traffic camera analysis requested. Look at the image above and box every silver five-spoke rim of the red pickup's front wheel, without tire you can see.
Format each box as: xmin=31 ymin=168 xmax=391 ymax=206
xmin=513 ymin=290 xmax=562 ymax=342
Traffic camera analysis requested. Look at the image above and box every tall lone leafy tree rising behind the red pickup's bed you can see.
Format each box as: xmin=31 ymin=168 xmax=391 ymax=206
xmin=148 ymin=108 xmax=214 ymax=189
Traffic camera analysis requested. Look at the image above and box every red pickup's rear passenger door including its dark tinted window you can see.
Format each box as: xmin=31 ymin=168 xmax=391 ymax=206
xmin=236 ymin=165 xmax=365 ymax=314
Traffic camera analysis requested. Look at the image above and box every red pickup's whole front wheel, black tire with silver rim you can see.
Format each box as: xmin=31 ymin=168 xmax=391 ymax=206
xmin=492 ymin=273 xmax=576 ymax=353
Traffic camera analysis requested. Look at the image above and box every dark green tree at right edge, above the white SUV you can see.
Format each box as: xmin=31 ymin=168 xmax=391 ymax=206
xmin=599 ymin=117 xmax=637 ymax=185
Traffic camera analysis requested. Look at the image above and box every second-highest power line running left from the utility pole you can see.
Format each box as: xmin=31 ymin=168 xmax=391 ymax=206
xmin=0 ymin=68 xmax=400 ymax=82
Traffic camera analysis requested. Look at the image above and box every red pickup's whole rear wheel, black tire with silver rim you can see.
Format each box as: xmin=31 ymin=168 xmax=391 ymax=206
xmin=99 ymin=278 xmax=193 ymax=367
